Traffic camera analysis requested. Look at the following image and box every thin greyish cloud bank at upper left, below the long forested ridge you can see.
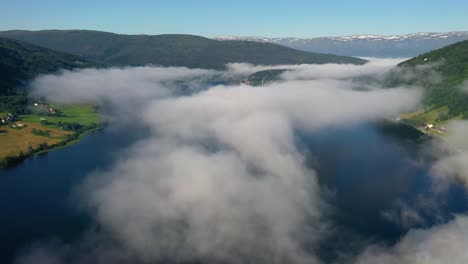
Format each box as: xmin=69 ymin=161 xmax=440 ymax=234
xmin=30 ymin=67 xmax=219 ymax=123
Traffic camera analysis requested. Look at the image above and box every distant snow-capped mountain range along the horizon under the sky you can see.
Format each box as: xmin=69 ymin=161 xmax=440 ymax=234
xmin=215 ymin=31 xmax=468 ymax=57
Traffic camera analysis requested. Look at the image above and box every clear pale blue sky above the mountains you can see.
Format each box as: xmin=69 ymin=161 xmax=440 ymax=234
xmin=0 ymin=0 xmax=468 ymax=37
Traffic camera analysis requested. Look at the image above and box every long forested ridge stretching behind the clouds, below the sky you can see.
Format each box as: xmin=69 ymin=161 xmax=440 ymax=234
xmin=0 ymin=30 xmax=366 ymax=69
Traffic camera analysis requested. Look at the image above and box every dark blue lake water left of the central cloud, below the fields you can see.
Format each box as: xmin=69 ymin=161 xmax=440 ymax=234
xmin=0 ymin=129 xmax=145 ymax=263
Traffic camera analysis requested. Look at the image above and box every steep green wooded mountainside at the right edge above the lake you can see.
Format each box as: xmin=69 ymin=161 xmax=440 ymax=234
xmin=398 ymin=40 xmax=468 ymax=119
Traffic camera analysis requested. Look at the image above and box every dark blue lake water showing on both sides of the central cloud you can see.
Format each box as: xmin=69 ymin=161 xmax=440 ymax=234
xmin=0 ymin=122 xmax=468 ymax=263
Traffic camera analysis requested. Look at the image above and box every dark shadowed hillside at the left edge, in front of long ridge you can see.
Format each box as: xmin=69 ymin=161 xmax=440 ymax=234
xmin=0 ymin=35 xmax=99 ymax=112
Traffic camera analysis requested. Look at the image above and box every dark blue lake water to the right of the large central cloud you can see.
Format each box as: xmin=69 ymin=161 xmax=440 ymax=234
xmin=299 ymin=123 xmax=468 ymax=261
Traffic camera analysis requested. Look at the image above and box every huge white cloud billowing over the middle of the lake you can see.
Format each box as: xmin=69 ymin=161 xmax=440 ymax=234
xmin=88 ymin=80 xmax=418 ymax=263
